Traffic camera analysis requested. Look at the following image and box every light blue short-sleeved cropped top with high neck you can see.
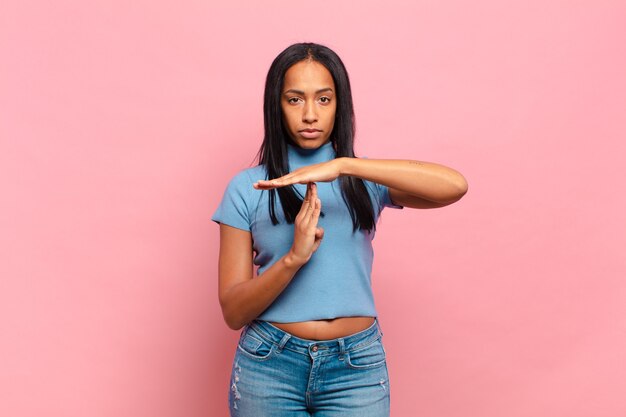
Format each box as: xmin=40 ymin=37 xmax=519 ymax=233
xmin=211 ymin=142 xmax=402 ymax=323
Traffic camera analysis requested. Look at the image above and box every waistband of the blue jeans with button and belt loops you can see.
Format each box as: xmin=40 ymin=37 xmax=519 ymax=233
xmin=246 ymin=318 xmax=383 ymax=355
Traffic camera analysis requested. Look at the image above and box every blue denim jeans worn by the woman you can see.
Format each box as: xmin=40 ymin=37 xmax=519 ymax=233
xmin=228 ymin=319 xmax=390 ymax=417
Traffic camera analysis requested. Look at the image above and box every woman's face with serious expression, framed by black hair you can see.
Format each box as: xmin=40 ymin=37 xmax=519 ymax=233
xmin=280 ymin=60 xmax=337 ymax=149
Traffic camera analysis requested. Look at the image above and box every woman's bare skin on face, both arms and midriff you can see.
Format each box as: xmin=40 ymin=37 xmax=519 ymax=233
xmin=219 ymin=60 xmax=467 ymax=340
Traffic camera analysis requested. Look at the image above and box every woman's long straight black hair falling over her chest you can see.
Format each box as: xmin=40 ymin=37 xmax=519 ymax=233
xmin=259 ymin=43 xmax=376 ymax=231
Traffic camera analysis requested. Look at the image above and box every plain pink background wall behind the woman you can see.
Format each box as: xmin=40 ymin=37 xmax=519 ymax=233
xmin=0 ymin=0 xmax=626 ymax=417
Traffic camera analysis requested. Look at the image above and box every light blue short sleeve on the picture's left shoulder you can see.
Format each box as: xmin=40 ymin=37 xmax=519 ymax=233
xmin=211 ymin=171 xmax=252 ymax=231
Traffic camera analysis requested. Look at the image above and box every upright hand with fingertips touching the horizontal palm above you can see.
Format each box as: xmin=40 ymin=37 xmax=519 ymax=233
xmin=289 ymin=182 xmax=324 ymax=265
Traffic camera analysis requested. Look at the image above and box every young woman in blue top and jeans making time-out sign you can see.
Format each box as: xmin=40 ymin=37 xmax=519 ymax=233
xmin=212 ymin=43 xmax=467 ymax=417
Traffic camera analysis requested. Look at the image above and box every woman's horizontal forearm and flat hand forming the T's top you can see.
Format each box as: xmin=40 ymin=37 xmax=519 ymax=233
xmin=254 ymin=157 xmax=467 ymax=208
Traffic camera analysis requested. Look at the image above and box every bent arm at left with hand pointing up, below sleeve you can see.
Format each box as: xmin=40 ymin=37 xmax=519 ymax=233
xmin=218 ymin=185 xmax=324 ymax=330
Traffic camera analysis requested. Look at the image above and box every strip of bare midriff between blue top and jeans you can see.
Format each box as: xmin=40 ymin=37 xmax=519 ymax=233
xmin=270 ymin=317 xmax=375 ymax=340
